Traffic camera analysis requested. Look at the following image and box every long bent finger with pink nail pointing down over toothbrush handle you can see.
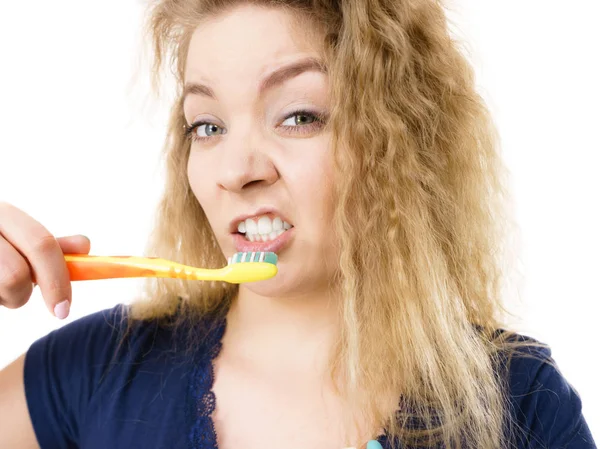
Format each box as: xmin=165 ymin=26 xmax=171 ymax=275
xmin=0 ymin=204 xmax=71 ymax=318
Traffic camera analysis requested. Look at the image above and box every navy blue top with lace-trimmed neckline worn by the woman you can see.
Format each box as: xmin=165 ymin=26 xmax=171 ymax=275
xmin=24 ymin=306 xmax=596 ymax=449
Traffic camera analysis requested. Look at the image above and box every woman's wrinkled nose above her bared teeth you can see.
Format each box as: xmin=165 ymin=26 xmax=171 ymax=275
xmin=217 ymin=124 xmax=279 ymax=193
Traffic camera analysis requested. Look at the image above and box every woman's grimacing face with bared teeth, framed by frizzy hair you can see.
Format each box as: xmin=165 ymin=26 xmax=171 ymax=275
xmin=184 ymin=5 xmax=337 ymax=297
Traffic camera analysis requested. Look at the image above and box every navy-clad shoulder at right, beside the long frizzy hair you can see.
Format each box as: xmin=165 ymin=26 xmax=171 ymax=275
xmin=492 ymin=331 xmax=596 ymax=448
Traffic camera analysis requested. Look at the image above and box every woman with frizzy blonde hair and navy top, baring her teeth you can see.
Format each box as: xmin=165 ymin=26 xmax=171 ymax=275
xmin=0 ymin=0 xmax=595 ymax=449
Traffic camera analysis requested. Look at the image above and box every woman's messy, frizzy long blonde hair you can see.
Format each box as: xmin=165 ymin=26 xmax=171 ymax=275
xmin=130 ymin=0 xmax=552 ymax=449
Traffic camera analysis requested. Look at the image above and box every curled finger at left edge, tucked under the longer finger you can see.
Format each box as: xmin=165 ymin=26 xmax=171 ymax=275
xmin=0 ymin=237 xmax=33 ymax=309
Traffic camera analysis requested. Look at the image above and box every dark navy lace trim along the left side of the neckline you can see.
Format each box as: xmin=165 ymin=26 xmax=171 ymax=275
xmin=187 ymin=319 xmax=226 ymax=449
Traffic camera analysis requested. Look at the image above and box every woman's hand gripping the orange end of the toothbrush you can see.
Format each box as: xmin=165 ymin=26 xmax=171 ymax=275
xmin=0 ymin=202 xmax=90 ymax=319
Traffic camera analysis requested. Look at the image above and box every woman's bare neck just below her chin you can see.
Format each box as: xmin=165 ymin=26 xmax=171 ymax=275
xmin=224 ymin=286 xmax=338 ymax=374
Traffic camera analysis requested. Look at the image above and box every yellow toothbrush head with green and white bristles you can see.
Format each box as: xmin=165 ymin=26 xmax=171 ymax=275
xmin=222 ymin=252 xmax=277 ymax=284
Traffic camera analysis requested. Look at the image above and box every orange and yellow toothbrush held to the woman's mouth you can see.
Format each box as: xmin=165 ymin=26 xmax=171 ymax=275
xmin=57 ymin=252 xmax=277 ymax=284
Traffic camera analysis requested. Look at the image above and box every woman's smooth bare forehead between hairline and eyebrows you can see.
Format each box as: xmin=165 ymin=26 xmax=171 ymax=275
xmin=185 ymin=5 xmax=321 ymax=83
